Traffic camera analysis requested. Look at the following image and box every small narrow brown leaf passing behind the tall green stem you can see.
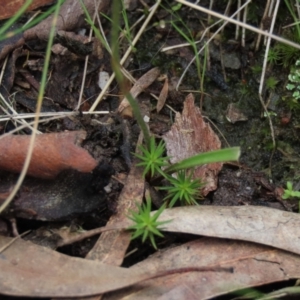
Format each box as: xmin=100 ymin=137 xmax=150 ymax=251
xmin=118 ymin=68 xmax=160 ymax=117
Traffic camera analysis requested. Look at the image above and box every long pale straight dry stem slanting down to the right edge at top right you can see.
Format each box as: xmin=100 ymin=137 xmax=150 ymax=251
xmin=176 ymin=0 xmax=300 ymax=49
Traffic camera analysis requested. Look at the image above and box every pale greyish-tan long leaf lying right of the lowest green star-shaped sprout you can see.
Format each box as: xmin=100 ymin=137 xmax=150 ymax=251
xmin=158 ymin=205 xmax=300 ymax=255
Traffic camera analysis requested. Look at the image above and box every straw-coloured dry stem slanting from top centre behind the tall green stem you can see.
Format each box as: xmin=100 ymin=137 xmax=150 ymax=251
xmin=89 ymin=0 xmax=161 ymax=112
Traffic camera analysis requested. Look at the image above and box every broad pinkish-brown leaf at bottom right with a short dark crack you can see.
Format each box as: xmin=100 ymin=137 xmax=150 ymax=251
xmin=104 ymin=238 xmax=300 ymax=300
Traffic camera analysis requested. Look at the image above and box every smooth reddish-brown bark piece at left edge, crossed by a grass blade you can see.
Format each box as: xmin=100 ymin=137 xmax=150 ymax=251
xmin=0 ymin=131 xmax=97 ymax=179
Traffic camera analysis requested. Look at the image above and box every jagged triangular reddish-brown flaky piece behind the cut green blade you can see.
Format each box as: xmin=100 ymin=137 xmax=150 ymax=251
xmin=163 ymin=94 xmax=223 ymax=196
